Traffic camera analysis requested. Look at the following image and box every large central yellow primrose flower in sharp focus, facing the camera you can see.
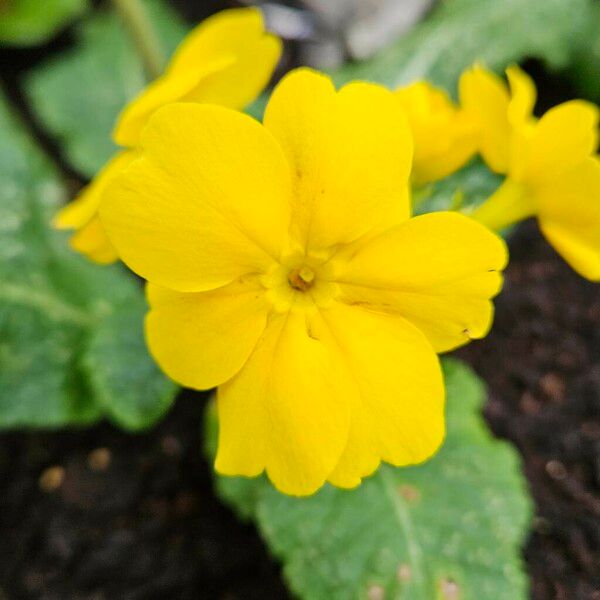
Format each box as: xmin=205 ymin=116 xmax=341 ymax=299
xmin=100 ymin=69 xmax=506 ymax=495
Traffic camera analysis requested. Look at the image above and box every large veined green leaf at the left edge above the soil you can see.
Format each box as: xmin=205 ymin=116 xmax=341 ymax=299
xmin=0 ymin=91 xmax=175 ymax=429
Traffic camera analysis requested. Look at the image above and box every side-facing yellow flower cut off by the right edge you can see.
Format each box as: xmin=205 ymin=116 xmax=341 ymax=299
xmin=460 ymin=66 xmax=600 ymax=281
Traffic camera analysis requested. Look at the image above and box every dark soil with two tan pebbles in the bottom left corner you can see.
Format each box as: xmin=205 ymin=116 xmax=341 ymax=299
xmin=0 ymin=393 xmax=286 ymax=600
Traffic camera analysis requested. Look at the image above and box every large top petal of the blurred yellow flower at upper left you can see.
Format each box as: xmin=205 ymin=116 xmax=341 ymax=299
xmin=114 ymin=8 xmax=281 ymax=146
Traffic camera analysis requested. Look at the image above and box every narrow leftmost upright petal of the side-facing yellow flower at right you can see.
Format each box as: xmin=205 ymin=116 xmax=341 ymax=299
xmin=459 ymin=65 xmax=511 ymax=173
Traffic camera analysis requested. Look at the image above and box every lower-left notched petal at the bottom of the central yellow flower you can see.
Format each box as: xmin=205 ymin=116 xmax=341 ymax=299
xmin=215 ymin=311 xmax=356 ymax=496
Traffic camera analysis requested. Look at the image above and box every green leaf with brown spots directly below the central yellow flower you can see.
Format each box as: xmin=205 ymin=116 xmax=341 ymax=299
xmin=208 ymin=360 xmax=531 ymax=600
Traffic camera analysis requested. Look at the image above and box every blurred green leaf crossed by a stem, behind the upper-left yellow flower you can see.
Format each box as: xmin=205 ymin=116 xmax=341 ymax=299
xmin=25 ymin=0 xmax=186 ymax=177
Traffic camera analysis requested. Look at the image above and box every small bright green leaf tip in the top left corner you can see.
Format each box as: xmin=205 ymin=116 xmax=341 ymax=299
xmin=0 ymin=0 xmax=88 ymax=46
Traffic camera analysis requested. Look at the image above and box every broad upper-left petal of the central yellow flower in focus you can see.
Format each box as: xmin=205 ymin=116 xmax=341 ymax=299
xmin=100 ymin=104 xmax=291 ymax=292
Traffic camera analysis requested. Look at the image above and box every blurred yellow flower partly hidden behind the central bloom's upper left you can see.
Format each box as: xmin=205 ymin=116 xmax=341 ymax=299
xmin=54 ymin=8 xmax=281 ymax=264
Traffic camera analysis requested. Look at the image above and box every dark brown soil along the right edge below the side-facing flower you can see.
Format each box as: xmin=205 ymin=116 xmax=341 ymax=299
xmin=460 ymin=223 xmax=600 ymax=600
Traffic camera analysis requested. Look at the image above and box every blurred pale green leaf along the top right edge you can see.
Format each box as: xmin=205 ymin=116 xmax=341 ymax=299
xmin=336 ymin=0 xmax=592 ymax=91
